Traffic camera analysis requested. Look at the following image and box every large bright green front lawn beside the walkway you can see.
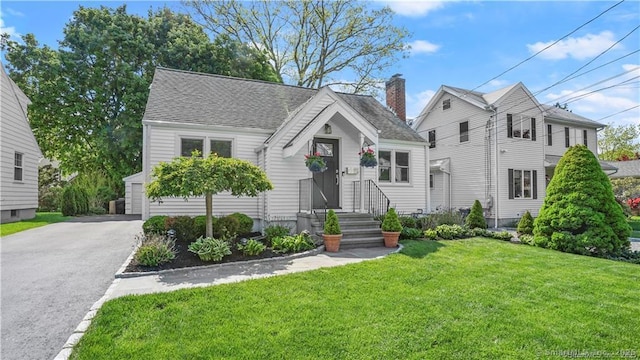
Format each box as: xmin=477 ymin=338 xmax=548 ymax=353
xmin=71 ymin=238 xmax=640 ymax=360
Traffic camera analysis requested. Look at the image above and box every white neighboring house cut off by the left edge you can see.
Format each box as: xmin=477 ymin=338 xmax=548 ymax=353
xmin=0 ymin=63 xmax=42 ymax=223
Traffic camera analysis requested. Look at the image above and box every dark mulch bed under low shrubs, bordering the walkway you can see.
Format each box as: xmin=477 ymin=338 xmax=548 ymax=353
xmin=124 ymin=233 xmax=316 ymax=273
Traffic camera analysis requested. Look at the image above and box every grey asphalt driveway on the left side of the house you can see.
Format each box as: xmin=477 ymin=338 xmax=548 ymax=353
xmin=0 ymin=215 xmax=142 ymax=360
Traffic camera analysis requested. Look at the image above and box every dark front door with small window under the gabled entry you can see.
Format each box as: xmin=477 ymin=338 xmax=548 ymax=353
xmin=313 ymin=138 xmax=340 ymax=209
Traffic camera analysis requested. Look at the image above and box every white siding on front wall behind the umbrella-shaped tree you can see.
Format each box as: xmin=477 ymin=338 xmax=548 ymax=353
xmin=145 ymin=125 xmax=266 ymax=220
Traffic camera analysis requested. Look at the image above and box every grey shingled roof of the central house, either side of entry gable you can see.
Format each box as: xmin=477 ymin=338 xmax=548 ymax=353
xmin=143 ymin=67 xmax=425 ymax=142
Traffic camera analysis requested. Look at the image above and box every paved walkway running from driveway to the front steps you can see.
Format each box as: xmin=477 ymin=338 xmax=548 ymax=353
xmin=105 ymin=247 xmax=398 ymax=300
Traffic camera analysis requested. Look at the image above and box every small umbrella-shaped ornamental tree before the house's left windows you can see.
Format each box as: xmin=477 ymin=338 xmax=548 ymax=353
xmin=146 ymin=151 xmax=273 ymax=237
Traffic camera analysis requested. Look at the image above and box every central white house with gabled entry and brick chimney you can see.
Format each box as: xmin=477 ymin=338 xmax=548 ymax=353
xmin=125 ymin=68 xmax=428 ymax=231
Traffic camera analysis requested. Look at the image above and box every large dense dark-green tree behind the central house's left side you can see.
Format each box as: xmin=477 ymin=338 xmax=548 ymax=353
xmin=2 ymin=5 xmax=277 ymax=194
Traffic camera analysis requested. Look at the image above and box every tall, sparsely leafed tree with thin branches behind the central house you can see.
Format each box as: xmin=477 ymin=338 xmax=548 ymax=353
xmin=185 ymin=0 xmax=409 ymax=93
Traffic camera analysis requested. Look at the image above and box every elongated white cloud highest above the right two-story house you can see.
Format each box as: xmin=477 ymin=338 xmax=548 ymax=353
xmin=527 ymin=31 xmax=621 ymax=60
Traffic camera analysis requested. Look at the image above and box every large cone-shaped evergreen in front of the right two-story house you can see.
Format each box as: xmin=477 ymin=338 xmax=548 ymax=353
xmin=533 ymin=145 xmax=631 ymax=256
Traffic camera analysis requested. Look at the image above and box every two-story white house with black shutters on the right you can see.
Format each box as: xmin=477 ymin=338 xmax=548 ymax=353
xmin=414 ymin=83 xmax=615 ymax=226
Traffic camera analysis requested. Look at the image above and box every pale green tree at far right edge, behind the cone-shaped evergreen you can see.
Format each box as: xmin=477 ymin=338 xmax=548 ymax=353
xmin=598 ymin=124 xmax=640 ymax=161
